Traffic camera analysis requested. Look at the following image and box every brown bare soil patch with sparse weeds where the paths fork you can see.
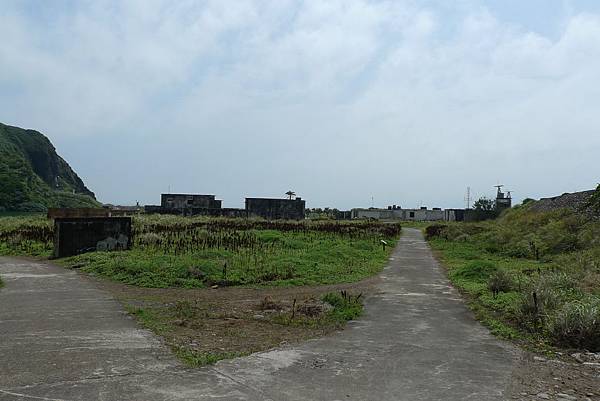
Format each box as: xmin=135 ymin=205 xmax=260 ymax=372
xmin=82 ymin=275 xmax=379 ymax=366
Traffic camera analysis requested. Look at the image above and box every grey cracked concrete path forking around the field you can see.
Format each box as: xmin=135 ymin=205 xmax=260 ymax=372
xmin=0 ymin=229 xmax=519 ymax=401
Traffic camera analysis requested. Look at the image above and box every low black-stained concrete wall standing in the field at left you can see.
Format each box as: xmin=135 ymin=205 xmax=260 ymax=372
xmin=54 ymin=217 xmax=131 ymax=258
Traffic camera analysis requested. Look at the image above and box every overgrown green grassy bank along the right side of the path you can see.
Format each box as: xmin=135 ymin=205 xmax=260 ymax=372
xmin=426 ymin=190 xmax=600 ymax=351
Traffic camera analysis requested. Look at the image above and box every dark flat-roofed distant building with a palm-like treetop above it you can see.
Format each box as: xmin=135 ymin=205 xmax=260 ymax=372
xmin=246 ymin=198 xmax=306 ymax=220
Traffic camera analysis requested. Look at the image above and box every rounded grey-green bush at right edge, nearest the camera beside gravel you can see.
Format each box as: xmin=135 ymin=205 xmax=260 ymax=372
xmin=550 ymin=299 xmax=600 ymax=352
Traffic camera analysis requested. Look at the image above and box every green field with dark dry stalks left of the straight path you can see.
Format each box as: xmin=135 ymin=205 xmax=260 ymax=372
xmin=0 ymin=216 xmax=400 ymax=288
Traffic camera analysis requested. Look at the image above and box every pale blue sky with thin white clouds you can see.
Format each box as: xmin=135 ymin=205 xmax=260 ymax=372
xmin=0 ymin=0 xmax=600 ymax=209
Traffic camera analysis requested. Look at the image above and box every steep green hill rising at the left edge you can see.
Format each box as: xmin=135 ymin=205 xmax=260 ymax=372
xmin=0 ymin=123 xmax=100 ymax=211
